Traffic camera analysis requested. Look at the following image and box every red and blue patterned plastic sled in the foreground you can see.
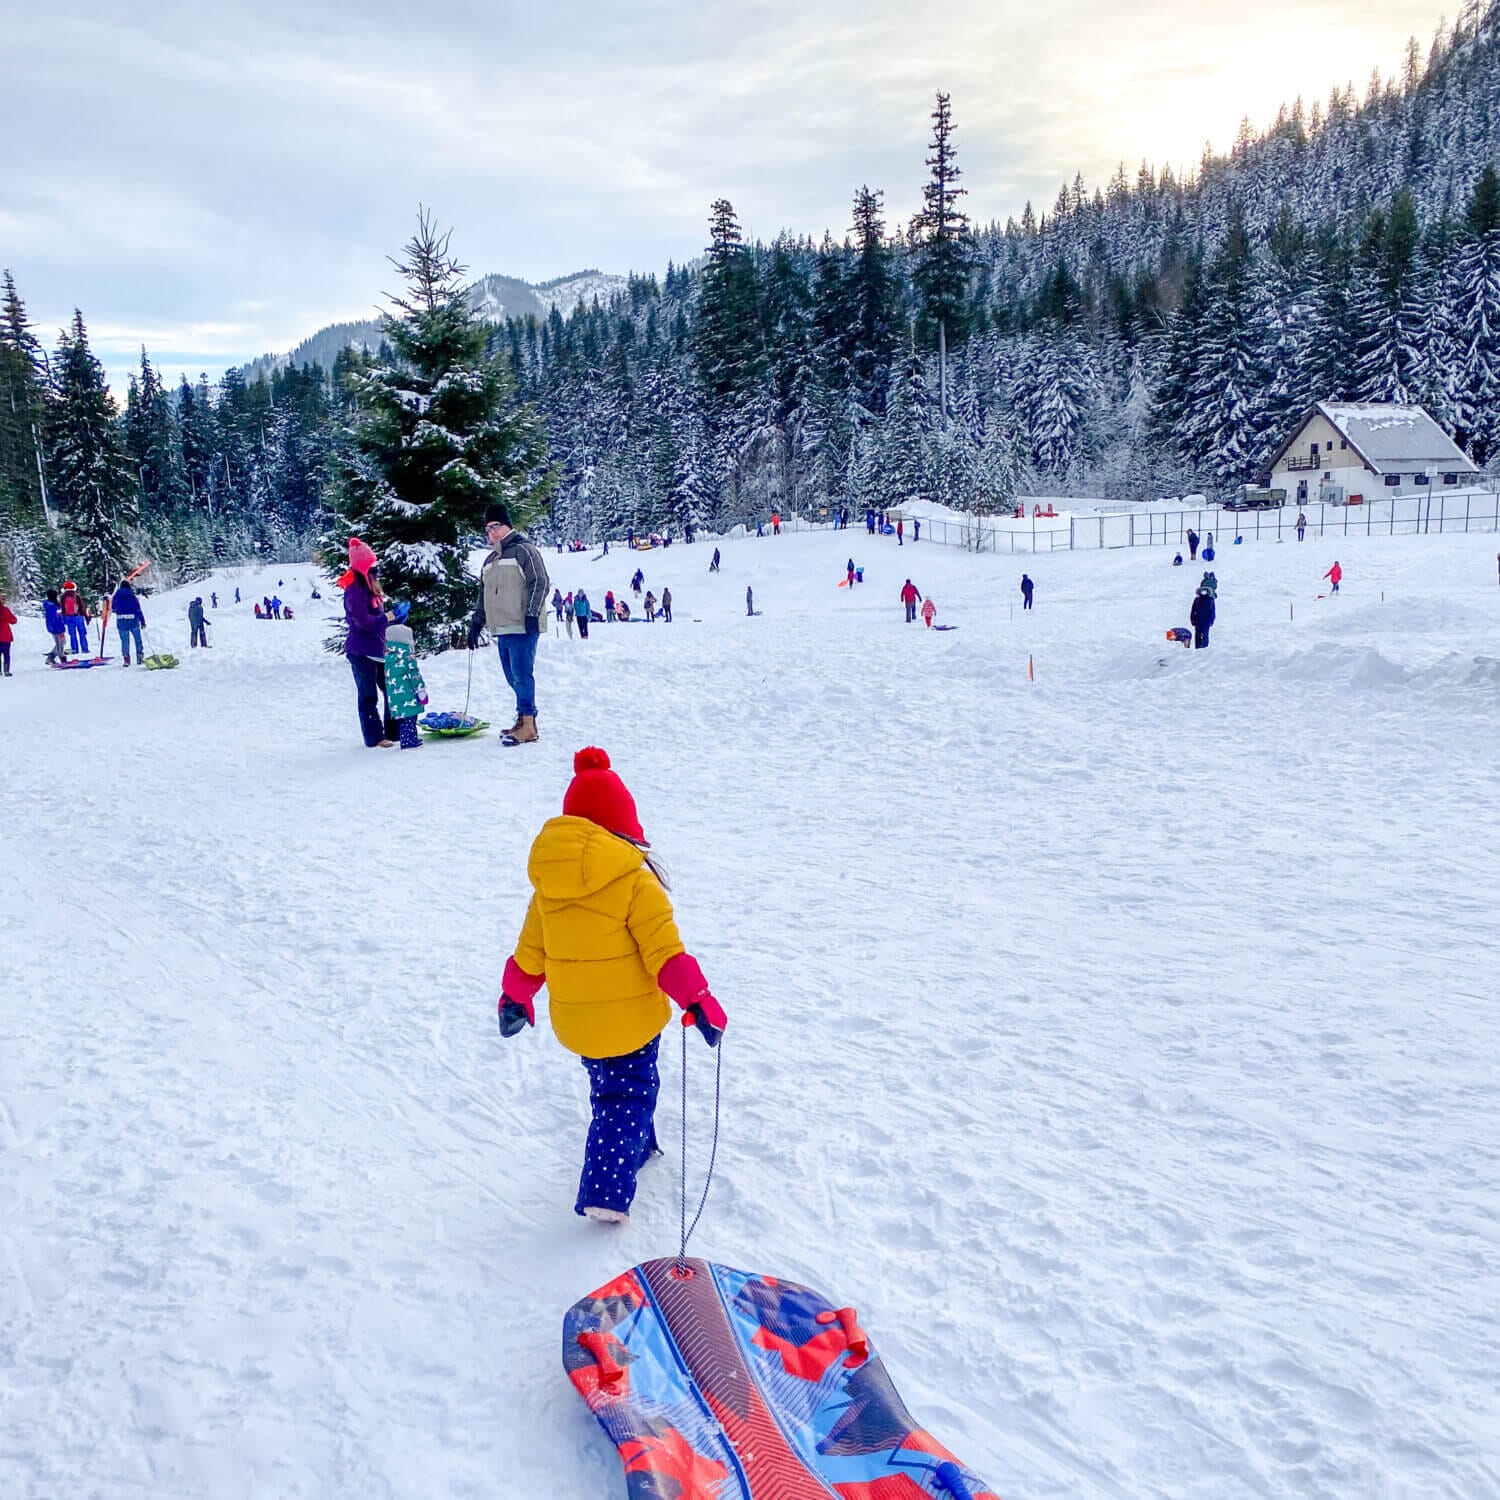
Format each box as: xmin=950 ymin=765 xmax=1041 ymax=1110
xmin=563 ymin=1259 xmax=998 ymax=1500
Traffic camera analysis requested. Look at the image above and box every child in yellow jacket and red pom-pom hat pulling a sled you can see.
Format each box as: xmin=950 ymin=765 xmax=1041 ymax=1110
xmin=500 ymin=747 xmax=726 ymax=1224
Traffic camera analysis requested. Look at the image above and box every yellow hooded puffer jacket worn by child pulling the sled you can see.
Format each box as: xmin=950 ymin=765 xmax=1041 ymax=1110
xmin=516 ymin=818 xmax=684 ymax=1058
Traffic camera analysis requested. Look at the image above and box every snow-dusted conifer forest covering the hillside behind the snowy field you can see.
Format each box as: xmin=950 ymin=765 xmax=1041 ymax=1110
xmin=0 ymin=0 xmax=1500 ymax=596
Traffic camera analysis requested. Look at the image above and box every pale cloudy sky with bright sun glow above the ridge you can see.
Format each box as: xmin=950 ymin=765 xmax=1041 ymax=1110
xmin=0 ymin=0 xmax=1440 ymax=393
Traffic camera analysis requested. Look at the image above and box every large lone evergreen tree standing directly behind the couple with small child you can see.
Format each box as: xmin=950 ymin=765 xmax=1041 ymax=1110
xmin=327 ymin=212 xmax=557 ymax=647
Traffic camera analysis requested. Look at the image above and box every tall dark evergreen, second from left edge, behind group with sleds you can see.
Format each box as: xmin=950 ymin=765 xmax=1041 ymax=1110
xmin=48 ymin=309 xmax=138 ymax=593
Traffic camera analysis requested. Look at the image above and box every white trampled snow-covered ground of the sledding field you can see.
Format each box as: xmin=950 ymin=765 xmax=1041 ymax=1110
xmin=0 ymin=531 xmax=1500 ymax=1500
